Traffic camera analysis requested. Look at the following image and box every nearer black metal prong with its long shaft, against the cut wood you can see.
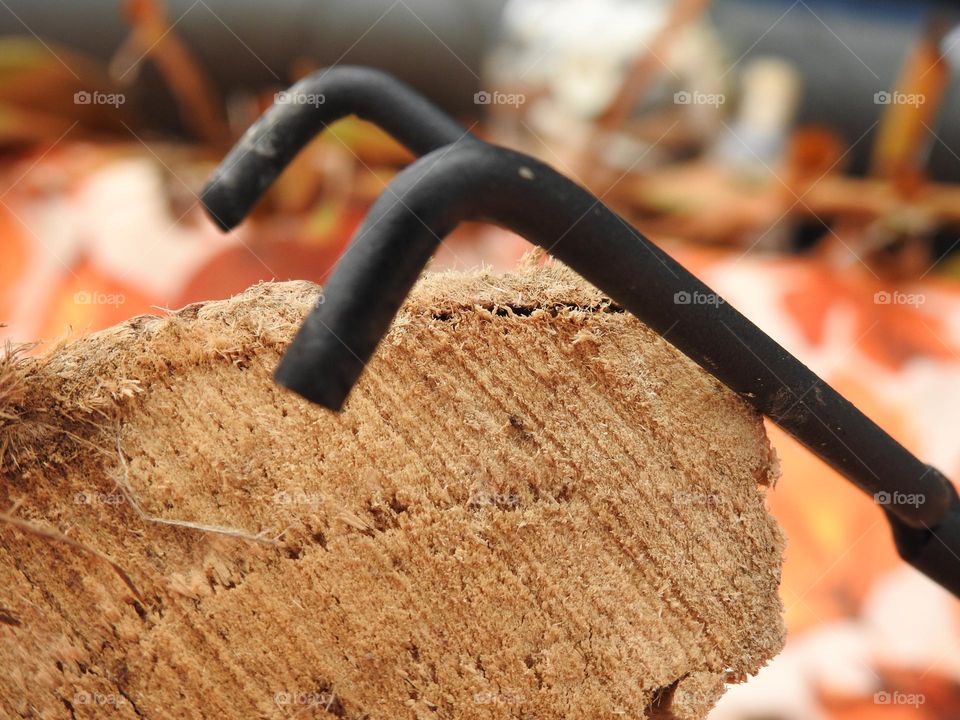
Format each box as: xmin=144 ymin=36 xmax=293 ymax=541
xmin=204 ymin=71 xmax=960 ymax=595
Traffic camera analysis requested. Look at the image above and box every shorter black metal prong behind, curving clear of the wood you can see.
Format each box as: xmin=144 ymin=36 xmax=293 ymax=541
xmin=201 ymin=65 xmax=473 ymax=230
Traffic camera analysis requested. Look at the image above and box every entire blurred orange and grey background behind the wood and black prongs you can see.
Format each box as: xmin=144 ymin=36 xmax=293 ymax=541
xmin=0 ymin=0 xmax=960 ymax=720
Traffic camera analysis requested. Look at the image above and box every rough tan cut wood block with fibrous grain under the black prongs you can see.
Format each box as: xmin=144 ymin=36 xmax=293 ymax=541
xmin=0 ymin=267 xmax=783 ymax=718
